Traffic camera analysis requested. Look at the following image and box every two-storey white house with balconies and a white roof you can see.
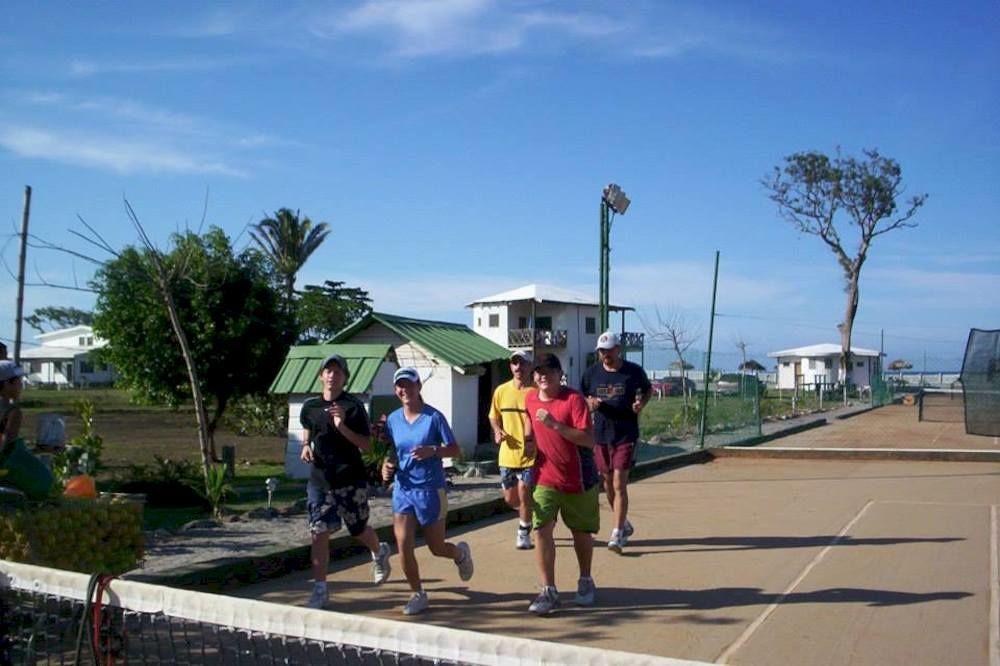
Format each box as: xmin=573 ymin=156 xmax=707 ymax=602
xmin=466 ymin=284 xmax=644 ymax=387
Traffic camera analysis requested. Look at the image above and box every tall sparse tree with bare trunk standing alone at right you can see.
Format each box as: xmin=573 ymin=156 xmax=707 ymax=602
xmin=761 ymin=149 xmax=927 ymax=396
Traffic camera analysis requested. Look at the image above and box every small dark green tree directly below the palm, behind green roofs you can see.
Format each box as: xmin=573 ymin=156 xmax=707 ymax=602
xmin=295 ymin=280 xmax=372 ymax=344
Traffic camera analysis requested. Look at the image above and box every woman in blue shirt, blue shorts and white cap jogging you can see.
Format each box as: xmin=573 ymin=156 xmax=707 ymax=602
xmin=383 ymin=368 xmax=473 ymax=615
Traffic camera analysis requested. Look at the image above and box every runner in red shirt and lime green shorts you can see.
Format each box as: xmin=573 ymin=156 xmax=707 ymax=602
xmin=524 ymin=354 xmax=601 ymax=615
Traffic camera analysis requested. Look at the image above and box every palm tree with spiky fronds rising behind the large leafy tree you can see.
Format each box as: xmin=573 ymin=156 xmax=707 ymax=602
xmin=250 ymin=208 xmax=330 ymax=312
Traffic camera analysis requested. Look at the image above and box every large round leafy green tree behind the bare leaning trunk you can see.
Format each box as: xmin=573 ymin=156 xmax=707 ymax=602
xmin=92 ymin=227 xmax=291 ymax=459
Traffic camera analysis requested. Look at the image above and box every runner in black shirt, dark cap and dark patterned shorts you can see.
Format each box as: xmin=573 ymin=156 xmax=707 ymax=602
xmin=299 ymin=354 xmax=392 ymax=608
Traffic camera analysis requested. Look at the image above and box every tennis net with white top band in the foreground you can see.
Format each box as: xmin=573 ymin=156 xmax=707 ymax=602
xmin=0 ymin=560 xmax=693 ymax=666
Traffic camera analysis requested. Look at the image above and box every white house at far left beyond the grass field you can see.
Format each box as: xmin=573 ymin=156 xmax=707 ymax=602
xmin=21 ymin=325 xmax=115 ymax=387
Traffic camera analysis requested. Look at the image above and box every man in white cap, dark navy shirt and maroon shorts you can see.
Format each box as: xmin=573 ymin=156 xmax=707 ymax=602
xmin=580 ymin=331 xmax=651 ymax=553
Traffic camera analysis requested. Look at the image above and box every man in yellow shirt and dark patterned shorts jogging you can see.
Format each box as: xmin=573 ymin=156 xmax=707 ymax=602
xmin=489 ymin=351 xmax=535 ymax=550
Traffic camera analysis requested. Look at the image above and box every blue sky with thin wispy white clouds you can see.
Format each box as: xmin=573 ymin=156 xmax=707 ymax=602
xmin=0 ymin=0 xmax=1000 ymax=369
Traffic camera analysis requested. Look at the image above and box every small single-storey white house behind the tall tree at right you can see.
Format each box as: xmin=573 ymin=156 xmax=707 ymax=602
xmin=768 ymin=343 xmax=881 ymax=389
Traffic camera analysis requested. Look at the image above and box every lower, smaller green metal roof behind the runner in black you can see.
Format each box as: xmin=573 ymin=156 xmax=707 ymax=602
xmin=268 ymin=344 xmax=392 ymax=393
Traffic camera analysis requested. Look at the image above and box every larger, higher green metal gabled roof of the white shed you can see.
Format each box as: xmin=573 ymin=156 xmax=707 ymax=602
xmin=330 ymin=312 xmax=510 ymax=368
